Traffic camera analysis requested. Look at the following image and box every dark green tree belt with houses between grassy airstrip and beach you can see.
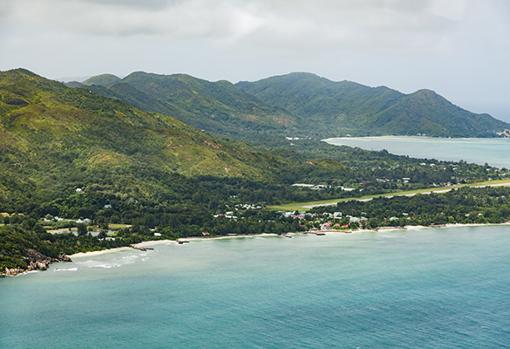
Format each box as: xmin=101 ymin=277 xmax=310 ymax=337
xmin=302 ymin=187 xmax=510 ymax=229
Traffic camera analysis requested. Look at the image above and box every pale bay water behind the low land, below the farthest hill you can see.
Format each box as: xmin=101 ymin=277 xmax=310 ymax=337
xmin=325 ymin=136 xmax=510 ymax=168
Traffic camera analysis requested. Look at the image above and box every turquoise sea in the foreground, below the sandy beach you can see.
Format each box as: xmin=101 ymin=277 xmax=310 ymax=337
xmin=0 ymin=226 xmax=510 ymax=349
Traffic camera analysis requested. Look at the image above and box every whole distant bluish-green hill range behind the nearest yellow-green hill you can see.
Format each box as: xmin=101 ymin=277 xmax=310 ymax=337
xmin=77 ymin=72 xmax=510 ymax=146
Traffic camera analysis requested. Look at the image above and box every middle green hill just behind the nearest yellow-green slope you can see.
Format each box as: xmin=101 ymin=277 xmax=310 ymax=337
xmin=81 ymin=72 xmax=296 ymax=141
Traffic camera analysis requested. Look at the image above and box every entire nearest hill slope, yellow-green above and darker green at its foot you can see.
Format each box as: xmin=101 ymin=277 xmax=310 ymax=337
xmin=0 ymin=69 xmax=302 ymax=212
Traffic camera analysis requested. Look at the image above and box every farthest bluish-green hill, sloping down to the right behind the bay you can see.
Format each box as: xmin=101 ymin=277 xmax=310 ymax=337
xmin=236 ymin=73 xmax=510 ymax=137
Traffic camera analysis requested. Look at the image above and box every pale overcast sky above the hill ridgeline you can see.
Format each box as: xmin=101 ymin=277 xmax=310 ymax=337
xmin=0 ymin=0 xmax=510 ymax=121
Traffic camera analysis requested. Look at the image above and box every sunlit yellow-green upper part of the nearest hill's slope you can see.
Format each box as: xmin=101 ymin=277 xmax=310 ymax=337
xmin=0 ymin=70 xmax=284 ymax=178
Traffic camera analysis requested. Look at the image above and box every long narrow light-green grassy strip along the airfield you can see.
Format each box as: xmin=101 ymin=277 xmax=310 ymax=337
xmin=268 ymin=178 xmax=510 ymax=212
